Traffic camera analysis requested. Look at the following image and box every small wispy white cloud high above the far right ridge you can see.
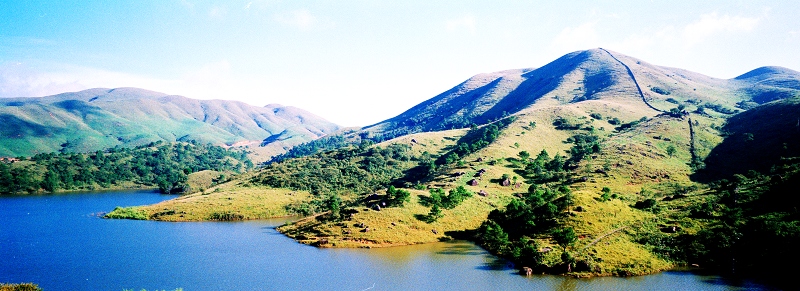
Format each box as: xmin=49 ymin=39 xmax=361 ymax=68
xmin=682 ymin=12 xmax=761 ymax=46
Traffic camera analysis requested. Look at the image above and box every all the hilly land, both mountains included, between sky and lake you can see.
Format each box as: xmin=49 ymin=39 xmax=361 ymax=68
xmin=0 ymin=48 xmax=800 ymax=276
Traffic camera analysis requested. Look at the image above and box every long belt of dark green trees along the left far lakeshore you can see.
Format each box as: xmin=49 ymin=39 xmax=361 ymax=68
xmin=0 ymin=141 xmax=253 ymax=194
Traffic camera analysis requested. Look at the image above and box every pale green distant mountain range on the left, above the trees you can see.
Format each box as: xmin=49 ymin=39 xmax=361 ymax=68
xmin=0 ymin=88 xmax=339 ymax=160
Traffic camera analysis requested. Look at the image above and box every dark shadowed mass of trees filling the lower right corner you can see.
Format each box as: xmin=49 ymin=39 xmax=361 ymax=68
xmin=640 ymin=161 xmax=800 ymax=275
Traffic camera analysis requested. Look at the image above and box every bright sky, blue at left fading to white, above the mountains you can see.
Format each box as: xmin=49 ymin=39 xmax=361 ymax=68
xmin=0 ymin=0 xmax=800 ymax=126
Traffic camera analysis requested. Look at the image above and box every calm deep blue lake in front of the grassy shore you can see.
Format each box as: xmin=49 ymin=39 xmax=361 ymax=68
xmin=0 ymin=191 xmax=768 ymax=291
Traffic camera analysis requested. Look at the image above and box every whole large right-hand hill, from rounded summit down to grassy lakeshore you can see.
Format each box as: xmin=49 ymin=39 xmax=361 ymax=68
xmin=103 ymin=49 xmax=800 ymax=276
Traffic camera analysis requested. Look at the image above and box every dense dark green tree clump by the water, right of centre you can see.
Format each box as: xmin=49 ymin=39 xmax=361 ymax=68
xmin=476 ymin=184 xmax=575 ymax=268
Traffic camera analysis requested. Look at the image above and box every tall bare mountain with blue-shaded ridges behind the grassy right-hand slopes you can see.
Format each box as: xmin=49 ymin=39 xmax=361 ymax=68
xmin=365 ymin=48 xmax=800 ymax=137
